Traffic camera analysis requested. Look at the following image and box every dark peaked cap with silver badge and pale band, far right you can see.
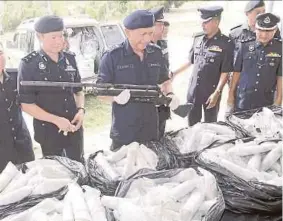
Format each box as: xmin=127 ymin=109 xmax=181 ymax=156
xmin=256 ymin=13 xmax=280 ymax=31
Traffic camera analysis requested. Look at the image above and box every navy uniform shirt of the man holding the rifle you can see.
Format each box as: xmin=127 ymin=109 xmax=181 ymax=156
xmin=98 ymin=40 xmax=168 ymax=144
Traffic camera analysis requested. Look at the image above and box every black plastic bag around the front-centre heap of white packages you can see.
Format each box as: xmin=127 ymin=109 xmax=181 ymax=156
xmin=115 ymin=168 xmax=225 ymax=221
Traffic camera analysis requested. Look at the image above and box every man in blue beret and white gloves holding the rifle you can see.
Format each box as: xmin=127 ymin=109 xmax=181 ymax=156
xmin=97 ymin=10 xmax=178 ymax=151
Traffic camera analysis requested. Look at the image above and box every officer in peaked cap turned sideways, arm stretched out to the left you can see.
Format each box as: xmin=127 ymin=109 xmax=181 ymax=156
xmin=173 ymin=6 xmax=234 ymax=126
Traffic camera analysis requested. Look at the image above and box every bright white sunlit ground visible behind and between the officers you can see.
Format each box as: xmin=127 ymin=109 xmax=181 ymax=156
xmin=2 ymin=1 xmax=251 ymax=157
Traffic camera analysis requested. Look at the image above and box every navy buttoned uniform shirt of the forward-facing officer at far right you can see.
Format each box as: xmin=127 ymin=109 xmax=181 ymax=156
xmin=234 ymin=39 xmax=282 ymax=109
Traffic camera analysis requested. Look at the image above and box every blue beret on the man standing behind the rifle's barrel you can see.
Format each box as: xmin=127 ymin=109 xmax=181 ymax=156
xmin=34 ymin=15 xmax=64 ymax=34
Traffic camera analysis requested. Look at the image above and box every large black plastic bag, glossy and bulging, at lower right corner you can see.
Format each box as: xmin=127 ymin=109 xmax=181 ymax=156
xmin=195 ymin=138 xmax=282 ymax=217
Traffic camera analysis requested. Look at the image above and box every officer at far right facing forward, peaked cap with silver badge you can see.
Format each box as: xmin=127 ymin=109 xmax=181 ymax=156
xmin=228 ymin=13 xmax=282 ymax=111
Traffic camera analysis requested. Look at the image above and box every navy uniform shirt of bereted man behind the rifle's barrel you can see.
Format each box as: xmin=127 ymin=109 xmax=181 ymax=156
xmin=18 ymin=50 xmax=82 ymax=143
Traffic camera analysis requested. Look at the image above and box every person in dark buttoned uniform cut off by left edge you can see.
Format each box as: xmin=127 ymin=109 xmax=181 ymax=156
xmin=0 ymin=43 xmax=34 ymax=173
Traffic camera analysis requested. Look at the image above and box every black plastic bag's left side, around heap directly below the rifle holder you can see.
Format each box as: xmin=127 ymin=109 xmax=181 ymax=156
xmin=87 ymin=150 xmax=119 ymax=196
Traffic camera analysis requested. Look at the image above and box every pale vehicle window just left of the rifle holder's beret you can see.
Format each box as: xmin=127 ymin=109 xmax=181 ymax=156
xmin=100 ymin=25 xmax=125 ymax=48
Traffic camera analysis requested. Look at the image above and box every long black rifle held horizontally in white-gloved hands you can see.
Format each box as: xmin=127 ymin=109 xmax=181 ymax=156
xmin=20 ymin=81 xmax=193 ymax=118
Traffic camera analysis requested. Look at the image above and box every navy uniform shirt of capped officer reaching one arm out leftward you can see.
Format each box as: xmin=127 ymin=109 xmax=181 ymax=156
xmin=187 ymin=31 xmax=234 ymax=104
